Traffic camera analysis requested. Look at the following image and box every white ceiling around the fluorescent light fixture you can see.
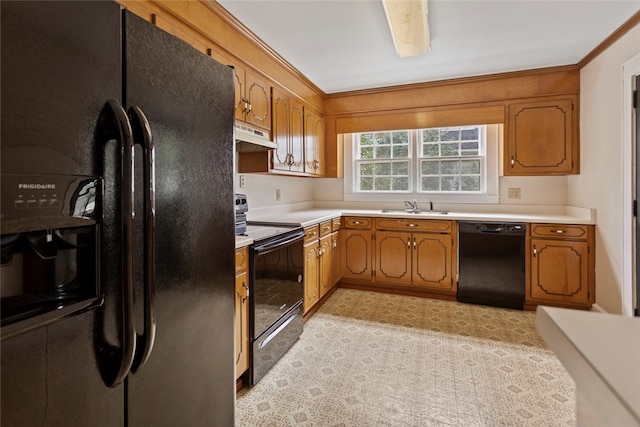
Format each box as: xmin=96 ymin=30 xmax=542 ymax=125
xmin=218 ymin=0 xmax=640 ymax=93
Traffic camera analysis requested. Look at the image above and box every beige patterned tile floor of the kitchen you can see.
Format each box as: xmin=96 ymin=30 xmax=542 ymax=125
xmin=236 ymin=289 xmax=575 ymax=427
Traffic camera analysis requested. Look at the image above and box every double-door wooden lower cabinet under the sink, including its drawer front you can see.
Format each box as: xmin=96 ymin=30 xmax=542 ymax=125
xmin=375 ymin=219 xmax=457 ymax=292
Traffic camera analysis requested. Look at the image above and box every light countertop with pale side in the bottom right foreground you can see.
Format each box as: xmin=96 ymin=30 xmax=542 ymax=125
xmin=537 ymin=306 xmax=640 ymax=426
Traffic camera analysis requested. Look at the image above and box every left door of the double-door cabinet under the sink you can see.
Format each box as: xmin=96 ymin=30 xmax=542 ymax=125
xmin=376 ymin=231 xmax=413 ymax=285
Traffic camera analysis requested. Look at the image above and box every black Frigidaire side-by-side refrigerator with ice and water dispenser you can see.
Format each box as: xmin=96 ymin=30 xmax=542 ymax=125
xmin=0 ymin=1 xmax=235 ymax=427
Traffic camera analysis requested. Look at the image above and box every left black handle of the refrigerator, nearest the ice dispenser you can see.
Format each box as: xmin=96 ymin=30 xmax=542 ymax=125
xmin=101 ymin=99 xmax=136 ymax=387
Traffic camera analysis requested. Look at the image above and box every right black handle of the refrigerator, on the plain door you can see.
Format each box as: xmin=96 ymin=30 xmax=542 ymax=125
xmin=129 ymin=106 xmax=156 ymax=372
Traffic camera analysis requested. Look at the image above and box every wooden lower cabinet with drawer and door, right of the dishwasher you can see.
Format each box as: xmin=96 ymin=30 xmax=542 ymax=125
xmin=525 ymin=224 xmax=595 ymax=309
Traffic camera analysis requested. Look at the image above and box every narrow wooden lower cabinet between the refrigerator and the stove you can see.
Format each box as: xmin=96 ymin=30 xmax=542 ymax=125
xmin=235 ymin=246 xmax=249 ymax=379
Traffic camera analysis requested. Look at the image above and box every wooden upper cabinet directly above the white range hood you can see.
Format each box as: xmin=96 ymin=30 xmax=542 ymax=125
xmin=234 ymin=64 xmax=271 ymax=130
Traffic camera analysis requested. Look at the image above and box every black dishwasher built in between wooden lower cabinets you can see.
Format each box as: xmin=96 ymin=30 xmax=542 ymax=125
xmin=458 ymin=221 xmax=526 ymax=310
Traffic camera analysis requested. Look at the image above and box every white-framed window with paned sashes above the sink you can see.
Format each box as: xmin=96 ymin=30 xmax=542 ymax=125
xmin=344 ymin=125 xmax=501 ymax=203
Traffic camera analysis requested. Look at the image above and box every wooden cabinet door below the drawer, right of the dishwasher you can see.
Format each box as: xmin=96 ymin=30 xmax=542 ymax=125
xmin=529 ymin=239 xmax=590 ymax=304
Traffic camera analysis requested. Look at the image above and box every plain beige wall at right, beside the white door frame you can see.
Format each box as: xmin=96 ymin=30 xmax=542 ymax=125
xmin=568 ymin=21 xmax=640 ymax=313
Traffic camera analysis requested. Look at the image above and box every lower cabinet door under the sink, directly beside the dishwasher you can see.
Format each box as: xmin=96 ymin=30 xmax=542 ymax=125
xmin=411 ymin=233 xmax=453 ymax=290
